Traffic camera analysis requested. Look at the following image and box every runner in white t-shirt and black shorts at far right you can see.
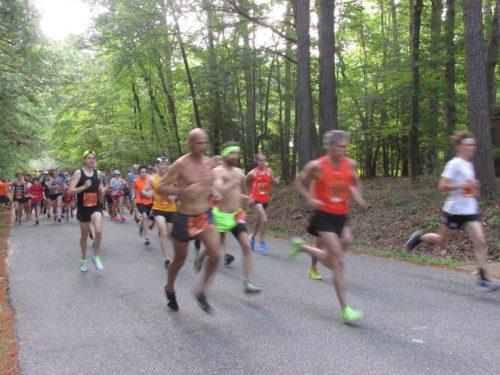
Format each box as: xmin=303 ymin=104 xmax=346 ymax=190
xmin=405 ymin=131 xmax=500 ymax=290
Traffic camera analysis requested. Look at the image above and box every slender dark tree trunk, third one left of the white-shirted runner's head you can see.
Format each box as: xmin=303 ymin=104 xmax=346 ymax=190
xmin=410 ymin=0 xmax=423 ymax=180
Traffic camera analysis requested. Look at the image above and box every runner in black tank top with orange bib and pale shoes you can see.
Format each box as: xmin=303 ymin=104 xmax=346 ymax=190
xmin=69 ymin=151 xmax=104 ymax=272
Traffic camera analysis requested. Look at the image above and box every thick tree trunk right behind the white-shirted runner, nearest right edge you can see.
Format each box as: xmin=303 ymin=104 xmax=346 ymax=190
xmin=464 ymin=0 xmax=496 ymax=197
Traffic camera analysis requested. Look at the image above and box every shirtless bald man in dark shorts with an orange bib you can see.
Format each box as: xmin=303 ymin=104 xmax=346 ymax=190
xmin=157 ymin=128 xmax=220 ymax=313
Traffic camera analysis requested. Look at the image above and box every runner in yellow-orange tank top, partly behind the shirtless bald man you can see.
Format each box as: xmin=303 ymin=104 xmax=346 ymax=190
xmin=142 ymin=156 xmax=176 ymax=270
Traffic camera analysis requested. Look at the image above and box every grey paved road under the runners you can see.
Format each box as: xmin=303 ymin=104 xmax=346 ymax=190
xmin=9 ymin=214 xmax=500 ymax=375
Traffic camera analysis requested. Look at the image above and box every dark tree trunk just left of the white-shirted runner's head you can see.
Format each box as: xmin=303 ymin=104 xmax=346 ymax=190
xmin=444 ymin=0 xmax=457 ymax=161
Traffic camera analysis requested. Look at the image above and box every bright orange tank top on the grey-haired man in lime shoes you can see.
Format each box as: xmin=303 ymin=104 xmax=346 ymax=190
xmin=314 ymin=156 xmax=354 ymax=215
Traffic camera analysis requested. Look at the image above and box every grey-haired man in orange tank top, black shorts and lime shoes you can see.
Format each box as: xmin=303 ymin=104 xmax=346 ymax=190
xmin=289 ymin=130 xmax=365 ymax=323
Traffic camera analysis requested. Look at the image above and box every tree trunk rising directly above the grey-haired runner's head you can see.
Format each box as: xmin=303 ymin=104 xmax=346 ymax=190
xmin=318 ymin=0 xmax=339 ymax=138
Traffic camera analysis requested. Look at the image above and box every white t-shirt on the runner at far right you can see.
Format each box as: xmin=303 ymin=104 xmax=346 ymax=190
xmin=441 ymin=157 xmax=477 ymax=215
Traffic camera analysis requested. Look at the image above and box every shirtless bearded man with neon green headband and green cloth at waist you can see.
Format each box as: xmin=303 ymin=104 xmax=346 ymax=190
xmin=195 ymin=141 xmax=261 ymax=293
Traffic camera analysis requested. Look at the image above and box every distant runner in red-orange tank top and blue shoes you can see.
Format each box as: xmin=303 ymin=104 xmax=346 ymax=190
xmin=246 ymin=153 xmax=279 ymax=253
